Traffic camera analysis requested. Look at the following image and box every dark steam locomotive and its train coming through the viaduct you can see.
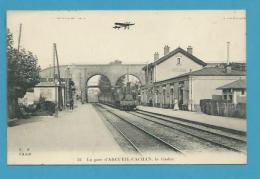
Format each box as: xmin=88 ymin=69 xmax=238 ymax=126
xmin=98 ymin=84 xmax=137 ymax=111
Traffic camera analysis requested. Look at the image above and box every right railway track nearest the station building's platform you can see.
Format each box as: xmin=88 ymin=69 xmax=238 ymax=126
xmin=128 ymin=112 xmax=246 ymax=153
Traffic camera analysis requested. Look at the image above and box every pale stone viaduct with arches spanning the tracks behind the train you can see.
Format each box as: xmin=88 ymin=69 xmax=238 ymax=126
xmin=40 ymin=64 xmax=145 ymax=100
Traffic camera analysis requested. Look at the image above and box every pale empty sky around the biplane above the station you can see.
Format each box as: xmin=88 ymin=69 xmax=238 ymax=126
xmin=7 ymin=10 xmax=246 ymax=68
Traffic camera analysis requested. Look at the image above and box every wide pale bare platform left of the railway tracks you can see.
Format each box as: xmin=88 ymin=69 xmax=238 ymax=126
xmin=7 ymin=104 xmax=123 ymax=164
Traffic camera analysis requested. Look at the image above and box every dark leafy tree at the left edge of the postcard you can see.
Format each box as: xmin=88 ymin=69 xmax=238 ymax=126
xmin=7 ymin=29 xmax=40 ymax=118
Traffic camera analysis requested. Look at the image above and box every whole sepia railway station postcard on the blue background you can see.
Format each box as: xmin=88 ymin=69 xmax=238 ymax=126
xmin=6 ymin=10 xmax=247 ymax=165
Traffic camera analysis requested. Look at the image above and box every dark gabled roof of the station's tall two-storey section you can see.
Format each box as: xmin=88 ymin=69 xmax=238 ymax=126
xmin=143 ymin=47 xmax=207 ymax=70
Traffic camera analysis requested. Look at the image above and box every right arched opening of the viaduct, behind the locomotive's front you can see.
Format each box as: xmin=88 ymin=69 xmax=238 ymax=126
xmin=115 ymin=74 xmax=141 ymax=104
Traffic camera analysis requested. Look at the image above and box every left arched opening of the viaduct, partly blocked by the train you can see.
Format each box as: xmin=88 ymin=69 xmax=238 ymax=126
xmin=86 ymin=75 xmax=111 ymax=103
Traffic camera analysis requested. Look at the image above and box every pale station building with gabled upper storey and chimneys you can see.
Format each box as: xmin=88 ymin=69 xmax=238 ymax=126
xmin=141 ymin=46 xmax=246 ymax=111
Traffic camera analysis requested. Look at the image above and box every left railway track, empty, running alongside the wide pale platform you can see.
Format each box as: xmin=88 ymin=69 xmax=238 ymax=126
xmin=96 ymin=105 xmax=183 ymax=155
